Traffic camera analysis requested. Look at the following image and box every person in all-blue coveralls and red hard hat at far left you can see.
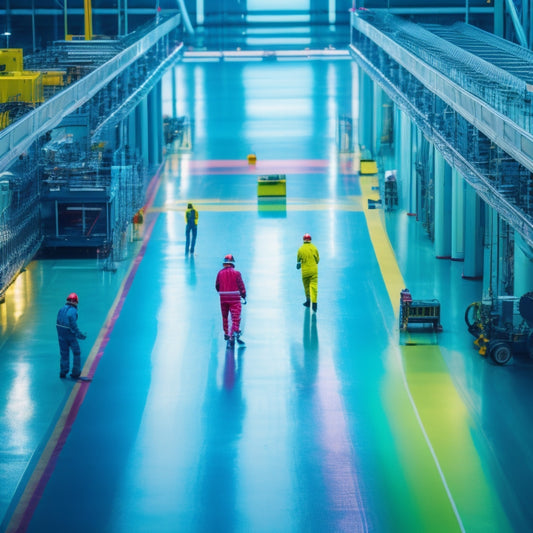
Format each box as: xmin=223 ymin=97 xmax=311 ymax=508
xmin=56 ymin=292 xmax=87 ymax=379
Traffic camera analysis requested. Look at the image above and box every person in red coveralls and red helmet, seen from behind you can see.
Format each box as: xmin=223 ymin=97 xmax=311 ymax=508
xmin=215 ymin=254 xmax=246 ymax=345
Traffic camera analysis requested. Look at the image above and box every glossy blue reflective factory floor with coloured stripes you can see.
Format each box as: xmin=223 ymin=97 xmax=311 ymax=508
xmin=0 ymin=60 xmax=533 ymax=533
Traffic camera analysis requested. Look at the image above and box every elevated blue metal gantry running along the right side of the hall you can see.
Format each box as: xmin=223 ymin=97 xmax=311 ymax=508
xmin=350 ymin=10 xmax=533 ymax=246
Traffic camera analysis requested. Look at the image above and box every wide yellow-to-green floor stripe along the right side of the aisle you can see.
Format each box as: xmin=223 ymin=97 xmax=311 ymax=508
xmin=360 ymin=176 xmax=512 ymax=533
